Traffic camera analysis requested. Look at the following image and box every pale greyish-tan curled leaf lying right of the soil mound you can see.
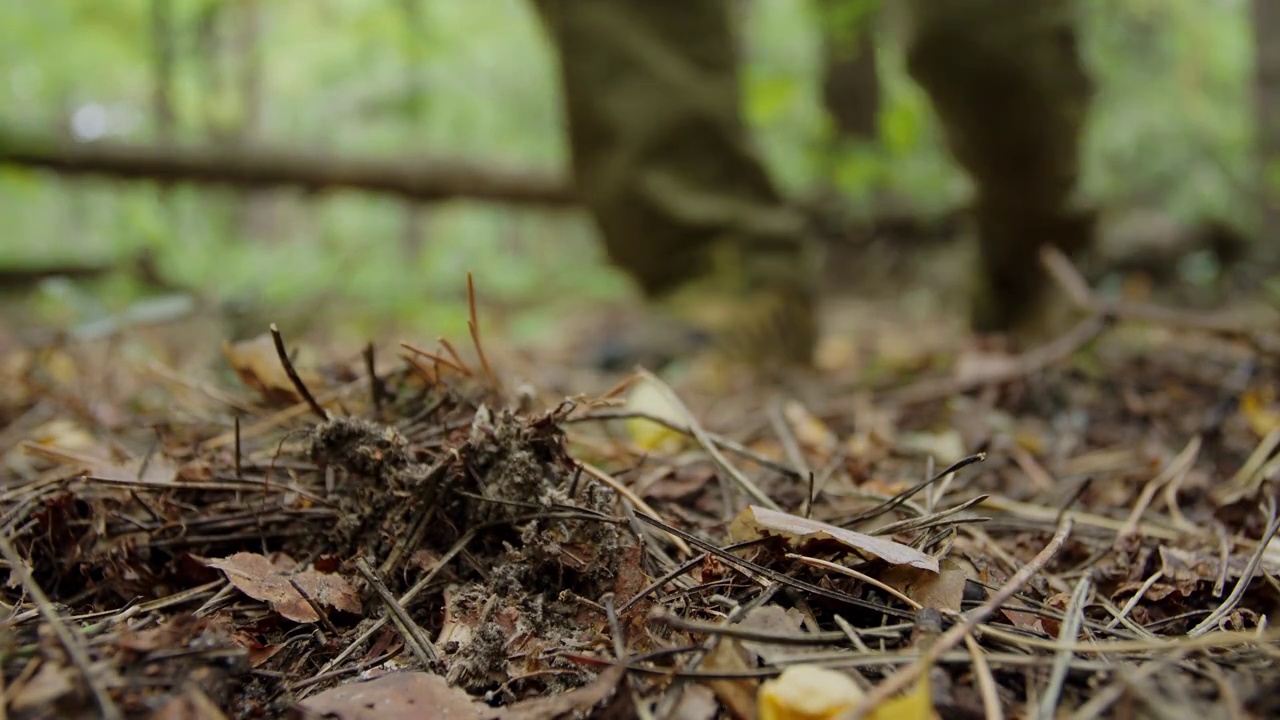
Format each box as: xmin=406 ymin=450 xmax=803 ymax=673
xmin=730 ymin=505 xmax=938 ymax=573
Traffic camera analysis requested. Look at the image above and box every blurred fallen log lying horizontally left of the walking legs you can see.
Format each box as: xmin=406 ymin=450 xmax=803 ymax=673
xmin=0 ymin=128 xmax=577 ymax=208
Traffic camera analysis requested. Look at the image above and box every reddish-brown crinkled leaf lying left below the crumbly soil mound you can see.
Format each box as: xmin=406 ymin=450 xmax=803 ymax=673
xmin=201 ymin=552 xmax=360 ymax=623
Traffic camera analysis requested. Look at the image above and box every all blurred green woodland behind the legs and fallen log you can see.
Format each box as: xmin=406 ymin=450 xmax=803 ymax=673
xmin=0 ymin=0 xmax=1264 ymax=348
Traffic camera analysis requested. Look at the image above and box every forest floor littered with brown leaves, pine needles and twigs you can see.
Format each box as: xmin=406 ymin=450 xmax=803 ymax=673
xmin=0 ymin=248 xmax=1280 ymax=720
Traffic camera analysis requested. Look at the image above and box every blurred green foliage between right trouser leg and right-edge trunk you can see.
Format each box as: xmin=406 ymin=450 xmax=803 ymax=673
xmin=1082 ymin=0 xmax=1253 ymax=219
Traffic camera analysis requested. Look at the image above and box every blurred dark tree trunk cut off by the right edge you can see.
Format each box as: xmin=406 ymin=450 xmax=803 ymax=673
xmin=1252 ymin=0 xmax=1280 ymax=272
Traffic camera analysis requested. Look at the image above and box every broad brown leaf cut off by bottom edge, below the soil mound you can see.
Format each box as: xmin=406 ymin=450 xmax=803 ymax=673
xmin=298 ymin=673 xmax=495 ymax=720
